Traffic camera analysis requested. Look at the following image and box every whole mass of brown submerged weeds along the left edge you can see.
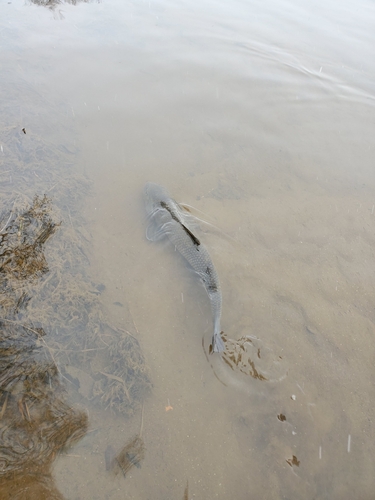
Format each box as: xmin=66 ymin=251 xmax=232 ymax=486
xmin=0 ymin=67 xmax=151 ymax=500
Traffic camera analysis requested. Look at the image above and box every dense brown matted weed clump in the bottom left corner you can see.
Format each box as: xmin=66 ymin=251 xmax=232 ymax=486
xmin=0 ymin=321 xmax=87 ymax=478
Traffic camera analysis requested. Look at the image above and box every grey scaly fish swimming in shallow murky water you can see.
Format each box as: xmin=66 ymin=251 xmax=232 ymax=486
xmin=144 ymin=182 xmax=225 ymax=352
